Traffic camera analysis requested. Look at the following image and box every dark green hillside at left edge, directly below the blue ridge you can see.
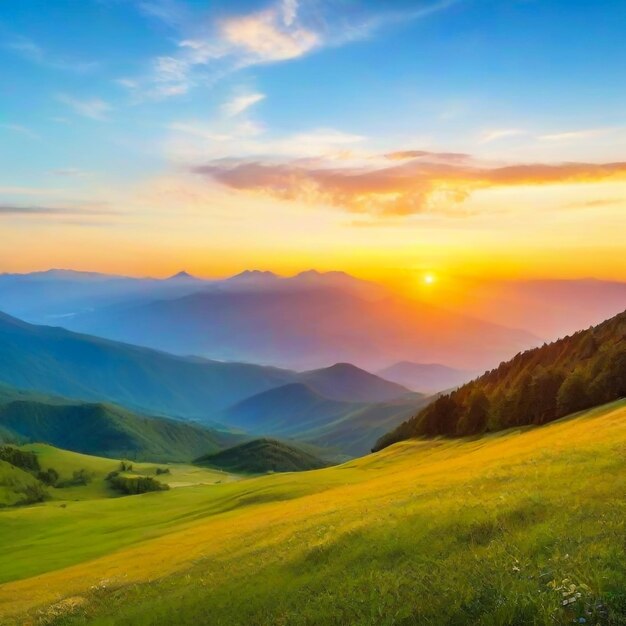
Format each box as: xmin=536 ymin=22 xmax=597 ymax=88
xmin=0 ymin=400 xmax=241 ymax=461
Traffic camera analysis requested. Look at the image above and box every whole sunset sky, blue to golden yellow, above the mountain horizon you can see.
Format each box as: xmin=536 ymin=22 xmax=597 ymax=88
xmin=0 ymin=0 xmax=626 ymax=283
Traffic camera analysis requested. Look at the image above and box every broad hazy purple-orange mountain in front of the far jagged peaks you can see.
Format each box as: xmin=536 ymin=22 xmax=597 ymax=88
xmin=63 ymin=279 xmax=539 ymax=371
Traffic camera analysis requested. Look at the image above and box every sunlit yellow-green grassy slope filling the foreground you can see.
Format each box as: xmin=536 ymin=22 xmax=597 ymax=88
xmin=0 ymin=401 xmax=626 ymax=626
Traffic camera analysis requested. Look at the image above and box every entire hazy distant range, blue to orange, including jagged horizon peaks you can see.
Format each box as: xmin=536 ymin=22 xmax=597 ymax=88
xmin=0 ymin=270 xmax=539 ymax=371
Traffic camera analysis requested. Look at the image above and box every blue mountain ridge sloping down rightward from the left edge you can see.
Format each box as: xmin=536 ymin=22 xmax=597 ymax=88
xmin=0 ymin=314 xmax=295 ymax=421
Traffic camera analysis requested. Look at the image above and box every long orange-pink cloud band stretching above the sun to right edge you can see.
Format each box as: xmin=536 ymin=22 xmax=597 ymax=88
xmin=193 ymin=151 xmax=626 ymax=215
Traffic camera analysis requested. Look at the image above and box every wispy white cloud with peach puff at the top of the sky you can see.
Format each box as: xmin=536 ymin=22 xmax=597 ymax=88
xmin=123 ymin=0 xmax=457 ymax=100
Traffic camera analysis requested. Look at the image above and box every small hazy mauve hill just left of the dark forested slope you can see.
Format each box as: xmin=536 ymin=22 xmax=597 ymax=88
xmin=377 ymin=361 xmax=475 ymax=394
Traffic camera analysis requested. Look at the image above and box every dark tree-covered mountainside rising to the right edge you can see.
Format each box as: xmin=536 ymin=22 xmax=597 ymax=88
xmin=374 ymin=311 xmax=626 ymax=450
